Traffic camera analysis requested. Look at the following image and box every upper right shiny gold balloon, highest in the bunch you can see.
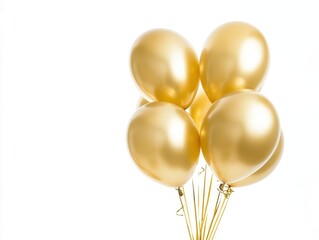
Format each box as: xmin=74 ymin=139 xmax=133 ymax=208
xmin=200 ymin=22 xmax=268 ymax=102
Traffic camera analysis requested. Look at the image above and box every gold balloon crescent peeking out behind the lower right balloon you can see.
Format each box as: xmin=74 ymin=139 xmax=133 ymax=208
xmin=231 ymin=133 xmax=284 ymax=187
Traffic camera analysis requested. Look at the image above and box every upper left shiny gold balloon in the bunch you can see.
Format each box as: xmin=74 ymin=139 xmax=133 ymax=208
xmin=131 ymin=29 xmax=199 ymax=109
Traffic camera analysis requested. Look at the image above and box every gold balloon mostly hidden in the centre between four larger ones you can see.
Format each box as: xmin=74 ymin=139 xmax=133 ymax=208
xmin=189 ymin=91 xmax=212 ymax=131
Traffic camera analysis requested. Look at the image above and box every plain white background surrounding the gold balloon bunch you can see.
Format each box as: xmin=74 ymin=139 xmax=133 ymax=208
xmin=0 ymin=0 xmax=319 ymax=240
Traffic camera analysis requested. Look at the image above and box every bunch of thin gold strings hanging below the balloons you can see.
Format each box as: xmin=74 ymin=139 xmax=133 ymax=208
xmin=176 ymin=166 xmax=233 ymax=240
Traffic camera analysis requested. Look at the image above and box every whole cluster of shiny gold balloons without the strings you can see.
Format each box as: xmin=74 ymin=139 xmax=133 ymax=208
xmin=128 ymin=22 xmax=283 ymax=188
